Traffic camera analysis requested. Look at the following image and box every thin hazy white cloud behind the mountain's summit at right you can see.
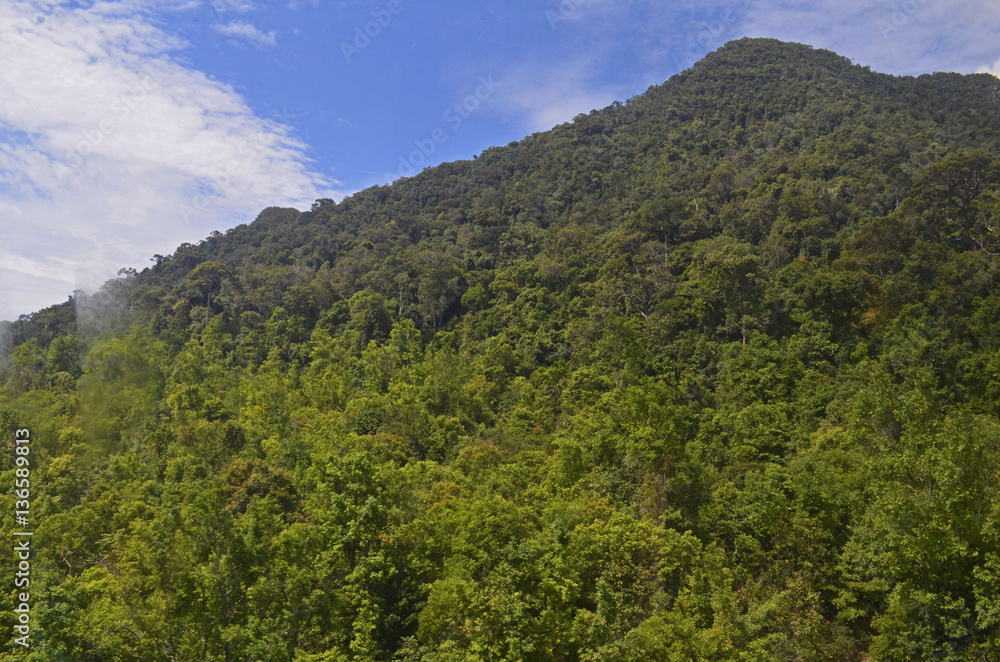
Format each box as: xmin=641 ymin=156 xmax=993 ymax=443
xmin=502 ymin=0 xmax=1000 ymax=136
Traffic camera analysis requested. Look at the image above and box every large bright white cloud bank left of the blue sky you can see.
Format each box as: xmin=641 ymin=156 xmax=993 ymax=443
xmin=0 ymin=2 xmax=340 ymax=319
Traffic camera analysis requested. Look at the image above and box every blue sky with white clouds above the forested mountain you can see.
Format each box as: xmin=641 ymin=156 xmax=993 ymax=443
xmin=0 ymin=0 xmax=1000 ymax=319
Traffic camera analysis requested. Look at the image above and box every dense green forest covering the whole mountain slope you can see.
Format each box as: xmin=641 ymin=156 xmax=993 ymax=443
xmin=0 ymin=39 xmax=1000 ymax=662
